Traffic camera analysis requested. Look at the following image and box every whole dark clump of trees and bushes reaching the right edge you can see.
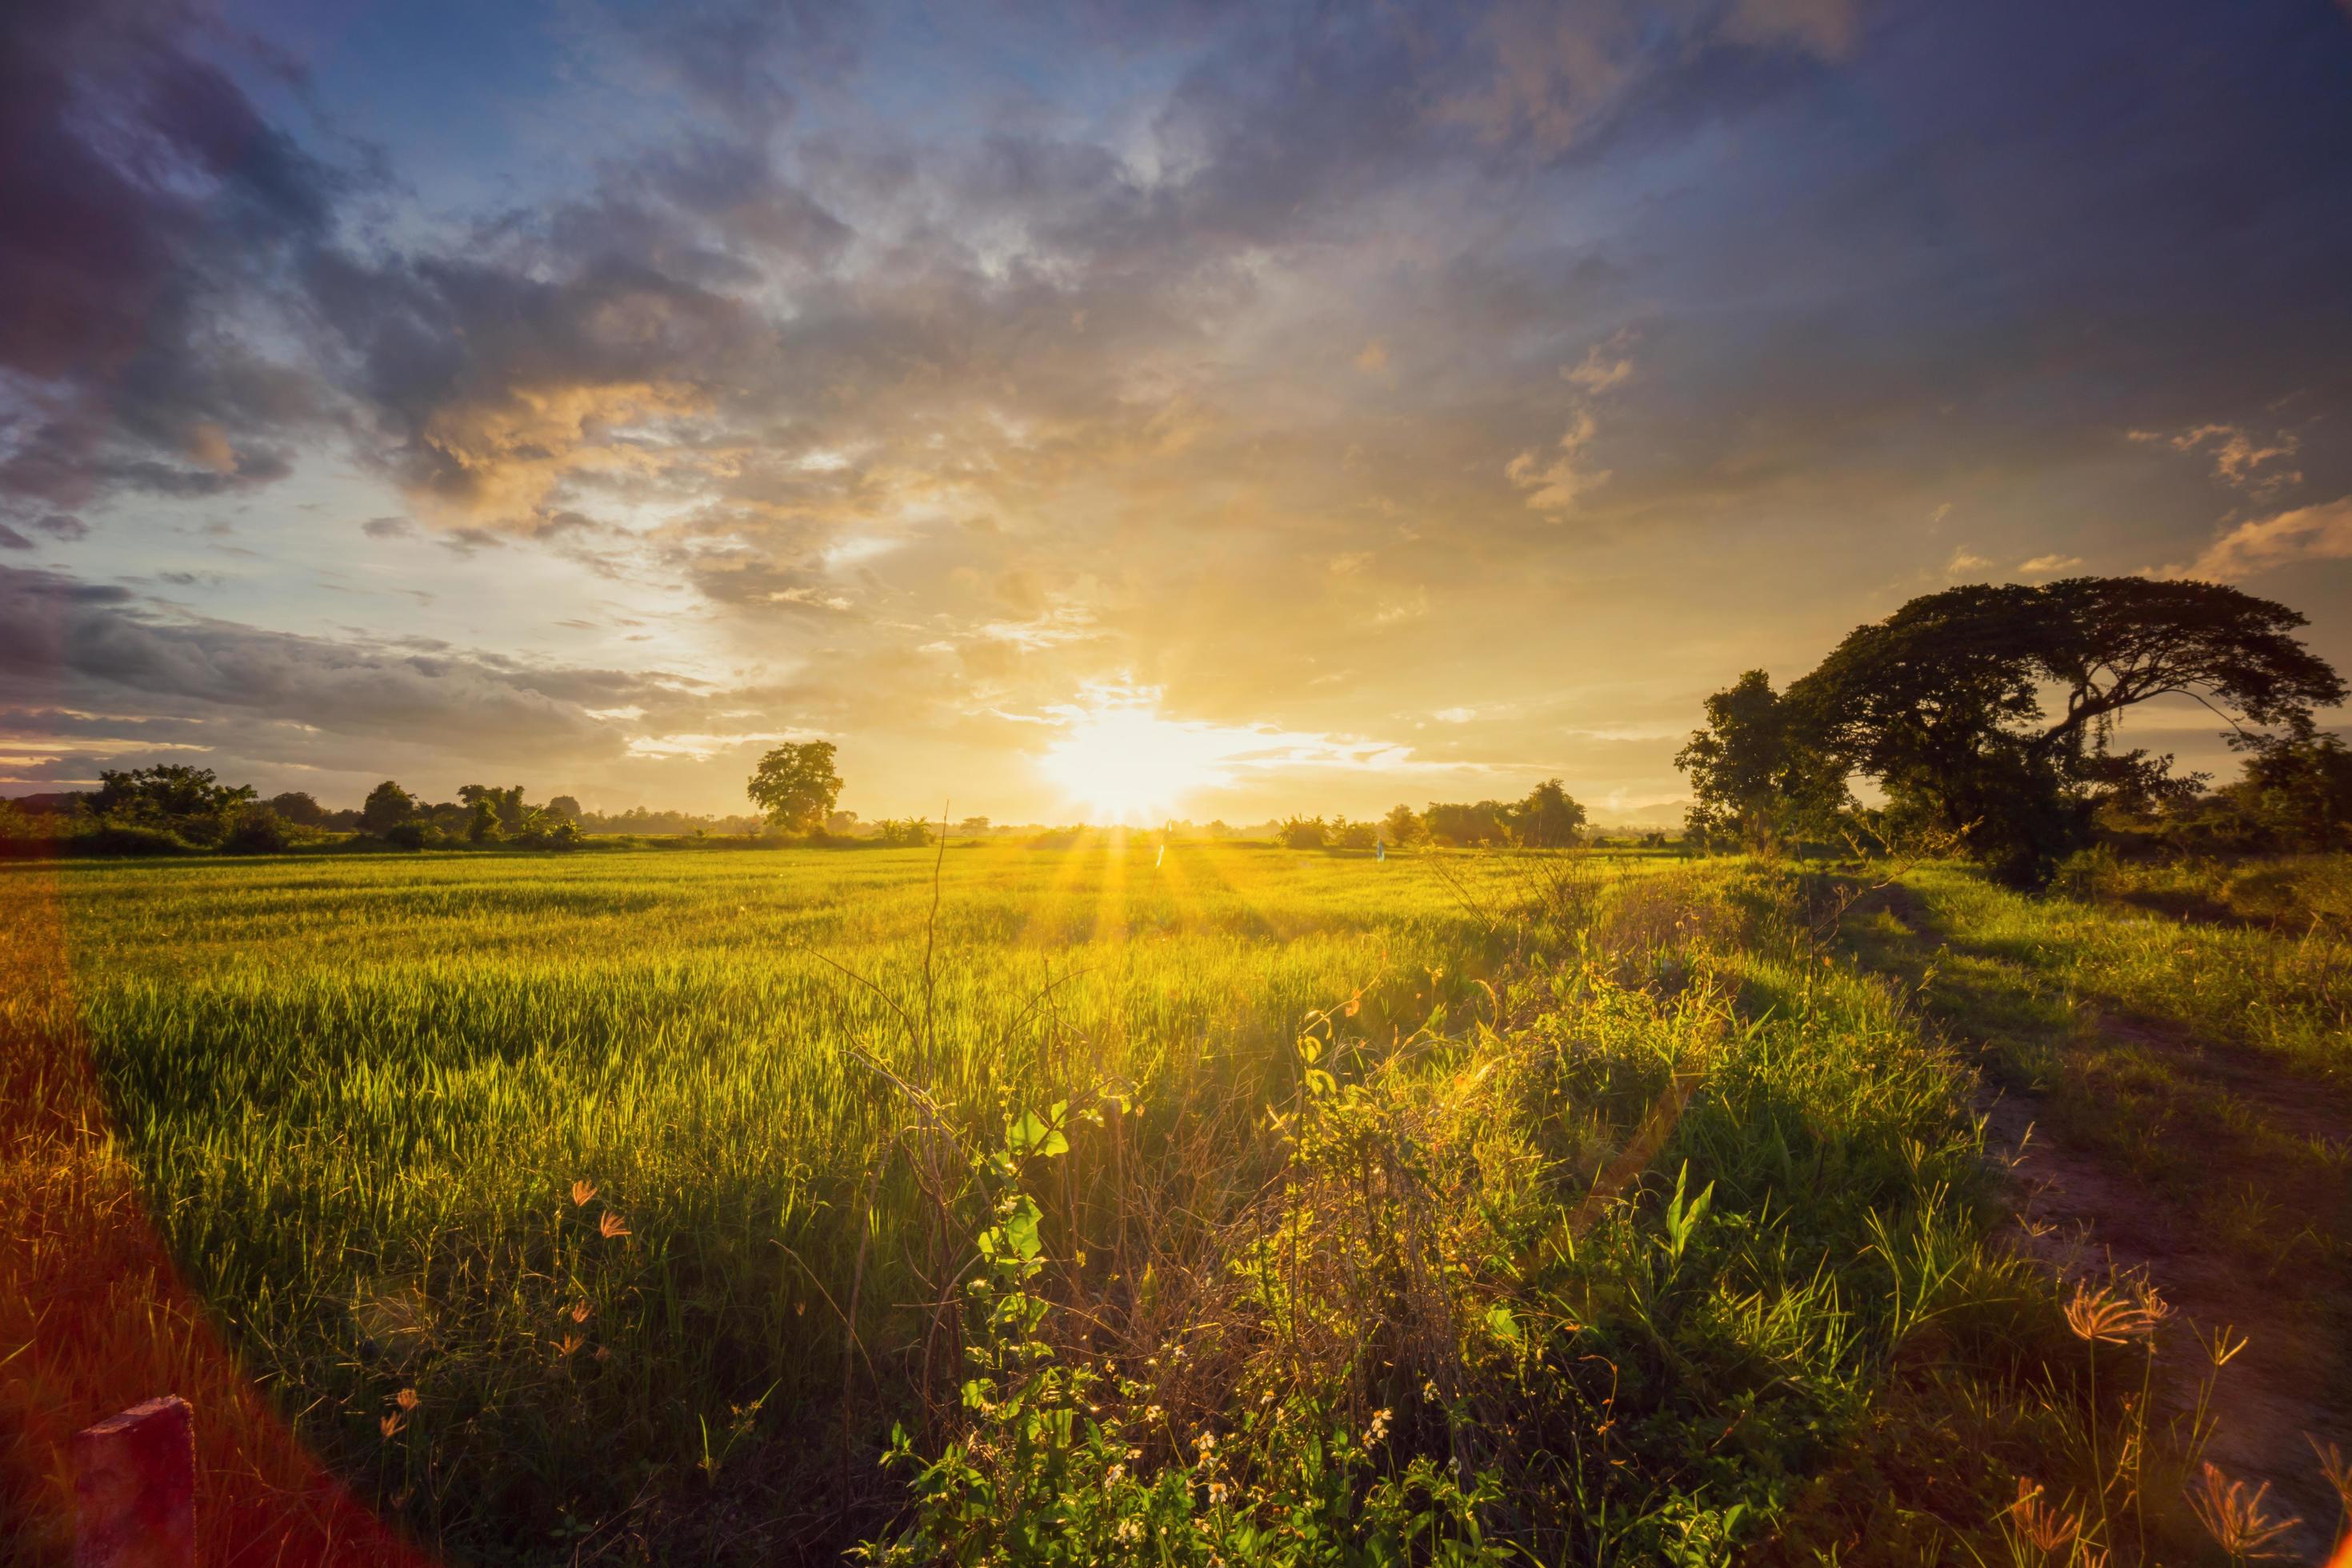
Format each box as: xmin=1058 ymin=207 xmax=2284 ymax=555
xmin=1677 ymin=578 xmax=2352 ymax=886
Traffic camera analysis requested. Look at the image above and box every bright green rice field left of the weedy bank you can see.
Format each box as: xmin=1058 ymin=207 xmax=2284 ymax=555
xmin=12 ymin=842 xmax=1599 ymax=1540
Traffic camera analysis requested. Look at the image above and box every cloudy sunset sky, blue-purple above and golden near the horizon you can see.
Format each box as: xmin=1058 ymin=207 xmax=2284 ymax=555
xmin=0 ymin=0 xmax=2352 ymax=822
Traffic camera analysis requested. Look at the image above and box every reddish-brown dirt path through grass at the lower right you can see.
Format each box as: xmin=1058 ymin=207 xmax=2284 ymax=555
xmin=1853 ymin=889 xmax=2352 ymax=1563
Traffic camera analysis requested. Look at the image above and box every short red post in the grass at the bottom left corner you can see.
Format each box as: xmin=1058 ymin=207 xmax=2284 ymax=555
xmin=73 ymin=1394 xmax=195 ymax=1568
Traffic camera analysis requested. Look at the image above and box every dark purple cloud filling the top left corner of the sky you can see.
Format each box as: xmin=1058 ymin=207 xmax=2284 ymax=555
xmin=0 ymin=0 xmax=343 ymax=508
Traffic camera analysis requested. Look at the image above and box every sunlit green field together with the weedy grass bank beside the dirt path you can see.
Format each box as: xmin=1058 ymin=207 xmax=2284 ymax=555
xmin=0 ymin=842 xmax=2342 ymax=1563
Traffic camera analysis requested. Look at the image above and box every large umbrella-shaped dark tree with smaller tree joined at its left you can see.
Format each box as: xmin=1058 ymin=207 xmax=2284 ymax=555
xmin=1682 ymin=578 xmax=2345 ymax=884
